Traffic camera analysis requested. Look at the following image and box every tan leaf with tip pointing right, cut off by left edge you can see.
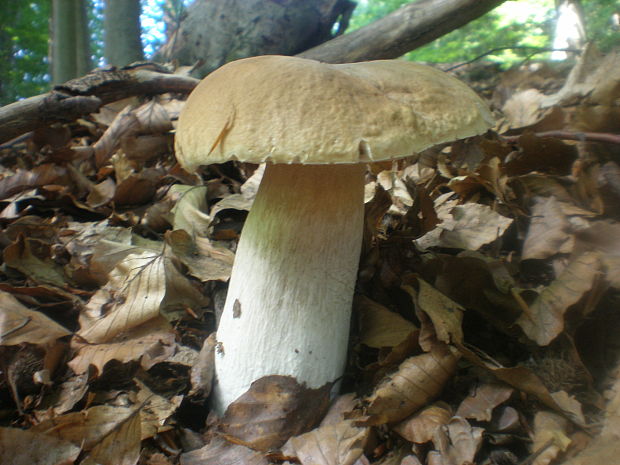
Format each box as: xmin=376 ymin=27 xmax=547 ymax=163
xmin=0 ymin=291 xmax=71 ymax=346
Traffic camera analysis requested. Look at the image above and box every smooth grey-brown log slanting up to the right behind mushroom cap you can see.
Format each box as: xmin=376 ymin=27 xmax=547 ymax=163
xmin=298 ymin=0 xmax=505 ymax=63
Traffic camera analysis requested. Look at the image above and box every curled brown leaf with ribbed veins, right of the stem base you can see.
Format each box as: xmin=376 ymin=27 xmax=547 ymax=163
xmin=366 ymin=344 xmax=458 ymax=425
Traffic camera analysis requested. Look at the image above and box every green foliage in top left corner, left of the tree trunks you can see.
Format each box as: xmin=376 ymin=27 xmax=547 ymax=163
xmin=0 ymin=0 xmax=50 ymax=105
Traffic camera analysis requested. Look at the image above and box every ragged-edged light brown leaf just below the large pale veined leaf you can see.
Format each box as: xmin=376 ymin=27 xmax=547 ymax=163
xmin=68 ymin=318 xmax=175 ymax=374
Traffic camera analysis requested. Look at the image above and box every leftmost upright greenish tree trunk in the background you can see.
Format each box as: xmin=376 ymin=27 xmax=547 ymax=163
xmin=52 ymin=0 xmax=77 ymax=84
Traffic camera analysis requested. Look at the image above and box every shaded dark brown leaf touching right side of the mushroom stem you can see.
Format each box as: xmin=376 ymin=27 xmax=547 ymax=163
xmin=355 ymin=296 xmax=417 ymax=349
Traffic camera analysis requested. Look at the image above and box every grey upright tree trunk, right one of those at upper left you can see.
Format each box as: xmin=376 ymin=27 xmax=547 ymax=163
xmin=103 ymin=0 xmax=144 ymax=67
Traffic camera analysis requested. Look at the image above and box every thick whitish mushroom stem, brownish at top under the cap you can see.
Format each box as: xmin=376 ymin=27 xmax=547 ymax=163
xmin=213 ymin=161 xmax=364 ymax=414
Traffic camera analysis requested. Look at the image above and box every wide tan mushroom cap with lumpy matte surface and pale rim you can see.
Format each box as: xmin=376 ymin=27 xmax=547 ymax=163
xmin=176 ymin=55 xmax=494 ymax=170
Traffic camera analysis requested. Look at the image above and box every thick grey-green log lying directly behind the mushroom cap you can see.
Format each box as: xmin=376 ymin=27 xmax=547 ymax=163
xmin=155 ymin=0 xmax=354 ymax=77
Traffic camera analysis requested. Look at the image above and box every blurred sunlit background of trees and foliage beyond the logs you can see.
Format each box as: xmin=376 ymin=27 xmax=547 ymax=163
xmin=0 ymin=0 xmax=620 ymax=105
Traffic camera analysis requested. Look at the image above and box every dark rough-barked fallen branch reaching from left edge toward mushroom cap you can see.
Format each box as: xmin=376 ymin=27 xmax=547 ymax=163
xmin=0 ymin=64 xmax=199 ymax=143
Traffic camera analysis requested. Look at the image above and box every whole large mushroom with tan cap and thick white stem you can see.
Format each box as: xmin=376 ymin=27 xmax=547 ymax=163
xmin=176 ymin=56 xmax=493 ymax=413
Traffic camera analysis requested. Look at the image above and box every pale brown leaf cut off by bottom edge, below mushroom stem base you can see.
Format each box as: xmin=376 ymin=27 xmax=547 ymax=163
xmin=181 ymin=437 xmax=269 ymax=465
